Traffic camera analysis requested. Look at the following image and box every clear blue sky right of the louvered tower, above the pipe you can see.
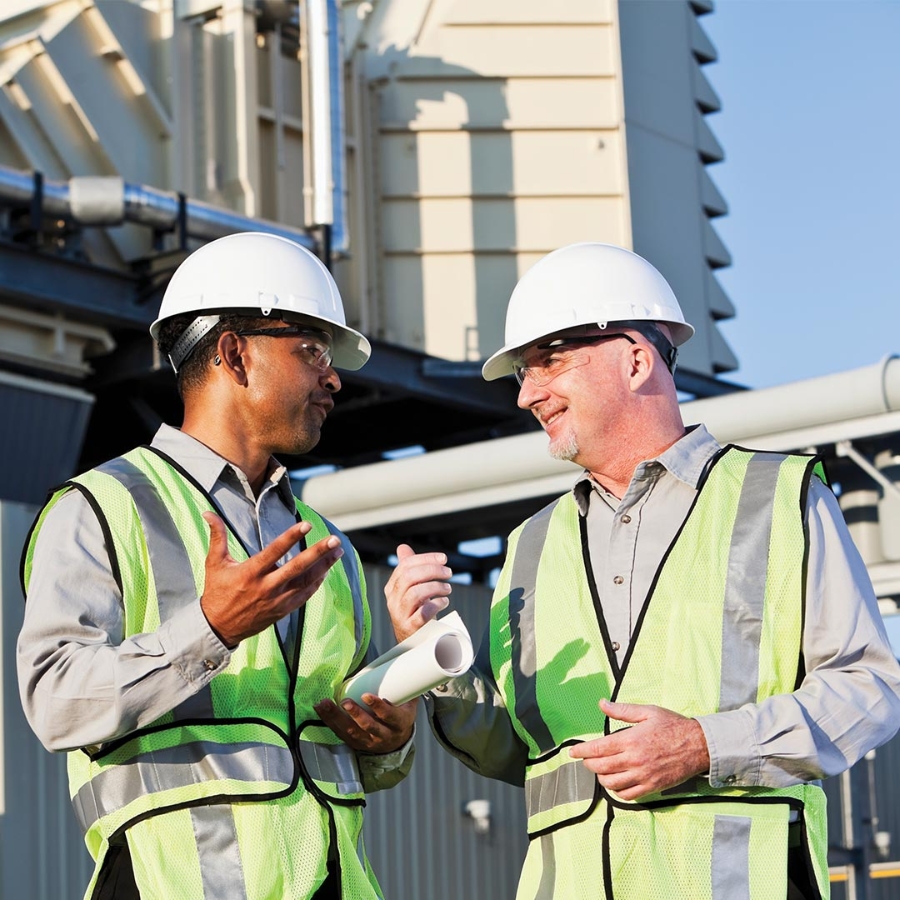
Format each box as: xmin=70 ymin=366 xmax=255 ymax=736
xmin=700 ymin=0 xmax=900 ymax=387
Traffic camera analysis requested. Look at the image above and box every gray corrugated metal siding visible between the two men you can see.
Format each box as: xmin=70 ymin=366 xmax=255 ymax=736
xmin=365 ymin=566 xmax=527 ymax=900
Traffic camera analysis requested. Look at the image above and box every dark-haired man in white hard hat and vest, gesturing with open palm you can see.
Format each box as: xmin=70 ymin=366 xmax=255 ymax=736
xmin=18 ymin=233 xmax=416 ymax=900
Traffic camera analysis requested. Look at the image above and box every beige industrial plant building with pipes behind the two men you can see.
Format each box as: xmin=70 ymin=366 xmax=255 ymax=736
xmin=0 ymin=0 xmax=900 ymax=900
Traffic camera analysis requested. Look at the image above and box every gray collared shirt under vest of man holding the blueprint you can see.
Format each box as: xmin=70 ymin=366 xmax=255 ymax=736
xmin=17 ymin=425 xmax=412 ymax=791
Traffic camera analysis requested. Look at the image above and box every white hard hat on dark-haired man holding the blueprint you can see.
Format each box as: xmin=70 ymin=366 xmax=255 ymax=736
xmin=150 ymin=231 xmax=372 ymax=370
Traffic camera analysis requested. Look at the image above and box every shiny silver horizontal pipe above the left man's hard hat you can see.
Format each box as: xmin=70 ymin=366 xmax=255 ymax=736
xmin=0 ymin=166 xmax=315 ymax=250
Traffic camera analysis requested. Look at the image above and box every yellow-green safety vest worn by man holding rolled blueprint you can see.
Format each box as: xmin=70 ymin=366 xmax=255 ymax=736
xmin=23 ymin=447 xmax=381 ymax=900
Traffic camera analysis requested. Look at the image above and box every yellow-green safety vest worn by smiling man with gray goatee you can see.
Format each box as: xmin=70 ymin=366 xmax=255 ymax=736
xmin=491 ymin=447 xmax=828 ymax=900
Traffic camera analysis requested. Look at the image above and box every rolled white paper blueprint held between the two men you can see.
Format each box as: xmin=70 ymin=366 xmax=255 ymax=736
xmin=339 ymin=612 xmax=475 ymax=707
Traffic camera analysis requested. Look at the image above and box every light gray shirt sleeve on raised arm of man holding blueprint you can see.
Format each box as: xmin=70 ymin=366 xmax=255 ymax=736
xmin=17 ymin=491 xmax=230 ymax=750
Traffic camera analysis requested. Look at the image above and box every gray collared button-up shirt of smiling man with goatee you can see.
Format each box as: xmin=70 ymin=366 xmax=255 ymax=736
xmin=429 ymin=425 xmax=900 ymax=787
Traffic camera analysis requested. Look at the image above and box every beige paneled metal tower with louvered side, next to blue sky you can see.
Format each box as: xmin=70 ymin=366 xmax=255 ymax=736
xmin=344 ymin=0 xmax=737 ymax=374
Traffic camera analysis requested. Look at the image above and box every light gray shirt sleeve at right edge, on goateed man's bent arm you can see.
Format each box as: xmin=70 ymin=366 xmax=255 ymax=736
xmin=698 ymin=481 xmax=900 ymax=787
